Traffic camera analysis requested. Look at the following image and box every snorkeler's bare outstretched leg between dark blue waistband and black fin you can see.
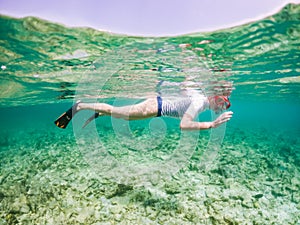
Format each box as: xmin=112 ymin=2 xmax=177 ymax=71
xmin=76 ymin=98 xmax=158 ymax=120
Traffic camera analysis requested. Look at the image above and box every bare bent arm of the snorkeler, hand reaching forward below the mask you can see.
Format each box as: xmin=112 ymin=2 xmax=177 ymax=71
xmin=180 ymin=111 xmax=233 ymax=130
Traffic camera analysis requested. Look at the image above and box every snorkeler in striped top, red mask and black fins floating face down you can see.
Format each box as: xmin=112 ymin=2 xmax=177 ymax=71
xmin=55 ymin=82 xmax=233 ymax=130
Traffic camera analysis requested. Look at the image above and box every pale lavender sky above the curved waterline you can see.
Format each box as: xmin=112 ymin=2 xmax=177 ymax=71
xmin=0 ymin=0 xmax=300 ymax=36
